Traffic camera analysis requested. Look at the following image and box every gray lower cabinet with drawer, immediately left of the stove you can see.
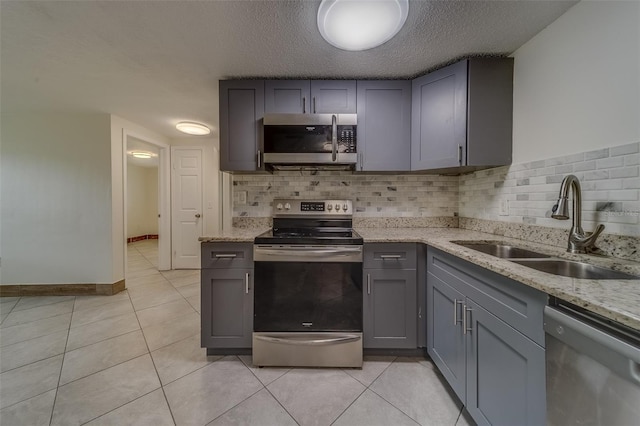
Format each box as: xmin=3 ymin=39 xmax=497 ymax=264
xmin=201 ymin=243 xmax=253 ymax=354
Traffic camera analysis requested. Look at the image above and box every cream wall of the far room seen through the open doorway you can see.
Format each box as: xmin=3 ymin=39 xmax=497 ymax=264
xmin=127 ymin=164 xmax=158 ymax=238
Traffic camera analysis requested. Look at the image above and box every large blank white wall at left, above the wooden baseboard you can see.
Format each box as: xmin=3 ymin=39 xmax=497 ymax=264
xmin=0 ymin=113 xmax=113 ymax=284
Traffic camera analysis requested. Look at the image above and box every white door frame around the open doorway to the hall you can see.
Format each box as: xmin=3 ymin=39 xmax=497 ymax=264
xmin=122 ymin=129 xmax=172 ymax=270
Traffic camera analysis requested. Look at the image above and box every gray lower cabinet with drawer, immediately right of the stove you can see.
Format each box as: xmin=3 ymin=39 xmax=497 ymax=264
xmin=363 ymin=243 xmax=418 ymax=349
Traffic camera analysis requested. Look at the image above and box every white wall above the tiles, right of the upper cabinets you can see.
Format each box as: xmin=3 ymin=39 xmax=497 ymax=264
xmin=513 ymin=0 xmax=640 ymax=164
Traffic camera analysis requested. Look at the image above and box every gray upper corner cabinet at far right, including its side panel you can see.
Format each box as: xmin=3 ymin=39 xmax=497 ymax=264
xmin=411 ymin=58 xmax=513 ymax=170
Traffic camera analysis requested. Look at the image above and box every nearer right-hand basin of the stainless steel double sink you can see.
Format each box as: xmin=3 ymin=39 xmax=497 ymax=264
xmin=512 ymin=259 xmax=640 ymax=280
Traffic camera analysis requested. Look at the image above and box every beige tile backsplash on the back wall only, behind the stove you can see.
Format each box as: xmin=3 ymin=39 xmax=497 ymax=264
xmin=233 ymin=171 xmax=458 ymax=218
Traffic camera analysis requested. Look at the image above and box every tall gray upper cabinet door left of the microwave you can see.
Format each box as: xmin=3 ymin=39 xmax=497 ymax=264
xmin=220 ymin=80 xmax=264 ymax=171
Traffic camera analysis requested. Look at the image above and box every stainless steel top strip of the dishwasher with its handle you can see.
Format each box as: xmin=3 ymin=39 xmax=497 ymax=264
xmin=544 ymin=306 xmax=640 ymax=385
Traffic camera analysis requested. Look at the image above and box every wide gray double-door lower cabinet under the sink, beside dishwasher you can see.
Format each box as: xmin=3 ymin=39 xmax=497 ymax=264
xmin=427 ymin=247 xmax=546 ymax=425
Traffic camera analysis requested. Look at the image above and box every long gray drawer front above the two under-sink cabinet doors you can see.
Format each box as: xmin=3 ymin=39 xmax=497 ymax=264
xmin=427 ymin=247 xmax=547 ymax=347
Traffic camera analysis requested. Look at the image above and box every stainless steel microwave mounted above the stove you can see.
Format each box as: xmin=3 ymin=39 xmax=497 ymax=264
xmin=263 ymin=114 xmax=358 ymax=170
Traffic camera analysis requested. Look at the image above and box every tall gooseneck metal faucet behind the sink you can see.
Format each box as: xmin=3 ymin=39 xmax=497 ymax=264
xmin=551 ymin=175 xmax=606 ymax=256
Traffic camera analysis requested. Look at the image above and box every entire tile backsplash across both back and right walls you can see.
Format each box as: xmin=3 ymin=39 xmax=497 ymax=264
xmin=233 ymin=142 xmax=640 ymax=237
